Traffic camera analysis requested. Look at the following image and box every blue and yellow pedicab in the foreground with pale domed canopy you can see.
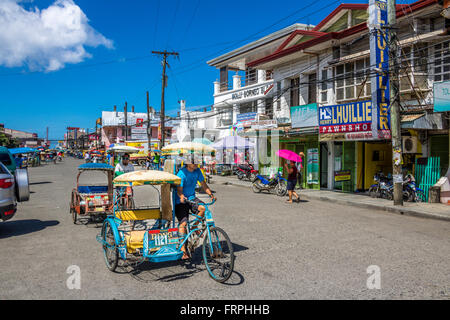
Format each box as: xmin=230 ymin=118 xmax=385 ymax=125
xmin=97 ymin=159 xmax=235 ymax=282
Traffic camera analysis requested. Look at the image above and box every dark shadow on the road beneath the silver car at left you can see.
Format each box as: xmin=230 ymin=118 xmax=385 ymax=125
xmin=0 ymin=219 xmax=59 ymax=239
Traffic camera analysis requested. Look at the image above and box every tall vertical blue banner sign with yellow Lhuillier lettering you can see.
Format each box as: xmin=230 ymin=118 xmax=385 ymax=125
xmin=369 ymin=0 xmax=391 ymax=139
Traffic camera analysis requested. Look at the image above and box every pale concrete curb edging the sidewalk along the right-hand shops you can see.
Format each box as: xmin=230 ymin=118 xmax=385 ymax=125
xmin=217 ymin=181 xmax=450 ymax=221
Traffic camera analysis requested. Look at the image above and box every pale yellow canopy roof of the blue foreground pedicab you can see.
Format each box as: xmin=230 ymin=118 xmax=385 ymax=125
xmin=113 ymin=170 xmax=181 ymax=186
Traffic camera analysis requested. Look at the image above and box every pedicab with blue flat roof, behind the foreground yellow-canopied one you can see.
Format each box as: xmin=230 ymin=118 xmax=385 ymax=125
xmin=70 ymin=163 xmax=114 ymax=224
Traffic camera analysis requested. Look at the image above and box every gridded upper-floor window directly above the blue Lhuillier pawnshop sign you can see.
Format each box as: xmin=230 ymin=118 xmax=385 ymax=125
xmin=335 ymin=58 xmax=371 ymax=101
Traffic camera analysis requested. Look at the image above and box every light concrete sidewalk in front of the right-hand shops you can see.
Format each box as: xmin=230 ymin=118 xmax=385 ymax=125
xmin=212 ymin=175 xmax=450 ymax=221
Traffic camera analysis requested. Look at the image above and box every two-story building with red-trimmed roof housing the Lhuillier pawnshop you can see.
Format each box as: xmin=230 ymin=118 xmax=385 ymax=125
xmin=211 ymin=0 xmax=450 ymax=195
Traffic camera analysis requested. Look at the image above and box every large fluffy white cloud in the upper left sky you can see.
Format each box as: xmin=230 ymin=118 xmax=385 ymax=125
xmin=0 ymin=0 xmax=113 ymax=71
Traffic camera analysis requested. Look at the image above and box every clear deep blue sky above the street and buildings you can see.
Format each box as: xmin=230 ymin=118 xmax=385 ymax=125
xmin=0 ymin=0 xmax=413 ymax=139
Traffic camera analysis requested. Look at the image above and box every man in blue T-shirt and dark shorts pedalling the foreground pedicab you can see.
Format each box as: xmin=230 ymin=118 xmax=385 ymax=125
xmin=175 ymin=156 xmax=216 ymax=260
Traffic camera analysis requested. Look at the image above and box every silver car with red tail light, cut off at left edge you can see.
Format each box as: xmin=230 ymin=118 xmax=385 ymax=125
xmin=0 ymin=162 xmax=17 ymax=221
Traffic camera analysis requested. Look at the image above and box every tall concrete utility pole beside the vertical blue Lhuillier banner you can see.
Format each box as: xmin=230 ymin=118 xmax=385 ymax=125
xmin=387 ymin=0 xmax=403 ymax=206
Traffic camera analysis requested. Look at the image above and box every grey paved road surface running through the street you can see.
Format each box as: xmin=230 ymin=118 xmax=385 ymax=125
xmin=0 ymin=158 xmax=450 ymax=299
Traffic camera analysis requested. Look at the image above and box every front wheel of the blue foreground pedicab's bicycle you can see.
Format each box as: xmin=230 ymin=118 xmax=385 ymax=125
xmin=203 ymin=227 xmax=235 ymax=283
